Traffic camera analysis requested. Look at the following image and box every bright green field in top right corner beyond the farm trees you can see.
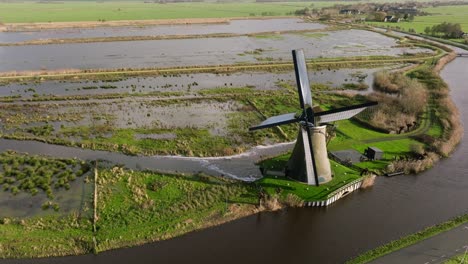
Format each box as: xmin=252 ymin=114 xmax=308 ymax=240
xmin=368 ymin=5 xmax=468 ymax=33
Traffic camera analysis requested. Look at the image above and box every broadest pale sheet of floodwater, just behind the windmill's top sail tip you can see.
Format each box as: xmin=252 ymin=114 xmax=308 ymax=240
xmin=0 ymin=30 xmax=430 ymax=71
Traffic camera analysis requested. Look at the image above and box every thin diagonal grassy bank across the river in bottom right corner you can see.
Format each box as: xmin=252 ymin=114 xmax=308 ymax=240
xmin=346 ymin=215 xmax=468 ymax=264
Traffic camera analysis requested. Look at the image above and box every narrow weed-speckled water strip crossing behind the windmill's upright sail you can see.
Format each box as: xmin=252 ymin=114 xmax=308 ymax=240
xmin=0 ymin=65 xmax=401 ymax=98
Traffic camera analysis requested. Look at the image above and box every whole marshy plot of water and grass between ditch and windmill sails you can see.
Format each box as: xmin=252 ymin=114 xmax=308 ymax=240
xmin=0 ymin=98 xmax=249 ymax=156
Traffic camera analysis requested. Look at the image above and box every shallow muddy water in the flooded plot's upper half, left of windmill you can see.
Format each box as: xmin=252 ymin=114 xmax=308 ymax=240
xmin=1 ymin=99 xmax=240 ymax=129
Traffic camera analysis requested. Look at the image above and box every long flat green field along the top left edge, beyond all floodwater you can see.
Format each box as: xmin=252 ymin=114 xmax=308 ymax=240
xmin=0 ymin=1 xmax=348 ymax=23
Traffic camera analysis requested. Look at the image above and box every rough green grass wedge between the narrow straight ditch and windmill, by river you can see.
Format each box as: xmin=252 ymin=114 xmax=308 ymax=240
xmin=96 ymin=170 xmax=258 ymax=251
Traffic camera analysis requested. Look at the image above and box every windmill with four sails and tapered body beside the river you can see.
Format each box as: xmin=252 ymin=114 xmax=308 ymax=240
xmin=249 ymin=49 xmax=377 ymax=186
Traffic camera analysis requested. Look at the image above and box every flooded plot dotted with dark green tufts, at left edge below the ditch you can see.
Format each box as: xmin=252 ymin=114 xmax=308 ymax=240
xmin=0 ymin=151 xmax=93 ymax=218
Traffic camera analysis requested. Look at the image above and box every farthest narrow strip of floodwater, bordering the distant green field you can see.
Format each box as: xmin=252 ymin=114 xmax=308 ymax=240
xmin=0 ymin=18 xmax=327 ymax=42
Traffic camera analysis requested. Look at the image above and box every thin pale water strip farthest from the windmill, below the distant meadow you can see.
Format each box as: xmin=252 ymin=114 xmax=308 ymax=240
xmin=0 ymin=18 xmax=326 ymax=43
